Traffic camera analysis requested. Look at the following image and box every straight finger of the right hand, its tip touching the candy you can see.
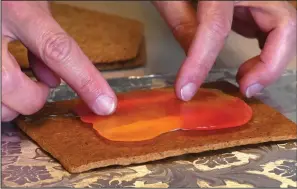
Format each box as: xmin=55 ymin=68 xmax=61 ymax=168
xmin=175 ymin=1 xmax=233 ymax=101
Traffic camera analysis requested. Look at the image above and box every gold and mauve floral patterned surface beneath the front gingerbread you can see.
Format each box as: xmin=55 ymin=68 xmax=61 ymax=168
xmin=1 ymin=70 xmax=297 ymax=188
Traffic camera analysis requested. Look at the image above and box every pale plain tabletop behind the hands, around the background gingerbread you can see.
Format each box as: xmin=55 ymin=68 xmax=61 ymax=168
xmin=59 ymin=1 xmax=296 ymax=78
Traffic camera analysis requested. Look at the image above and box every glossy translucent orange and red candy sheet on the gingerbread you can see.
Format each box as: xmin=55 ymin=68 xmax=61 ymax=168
xmin=75 ymin=89 xmax=252 ymax=141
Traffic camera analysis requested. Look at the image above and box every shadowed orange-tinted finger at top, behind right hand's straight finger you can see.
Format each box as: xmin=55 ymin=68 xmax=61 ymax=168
xmin=153 ymin=1 xmax=197 ymax=52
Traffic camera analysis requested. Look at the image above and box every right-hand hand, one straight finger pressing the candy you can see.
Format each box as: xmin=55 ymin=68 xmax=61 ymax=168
xmin=154 ymin=1 xmax=296 ymax=101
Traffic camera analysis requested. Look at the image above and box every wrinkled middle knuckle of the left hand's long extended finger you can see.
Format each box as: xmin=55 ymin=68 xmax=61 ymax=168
xmin=40 ymin=33 xmax=72 ymax=63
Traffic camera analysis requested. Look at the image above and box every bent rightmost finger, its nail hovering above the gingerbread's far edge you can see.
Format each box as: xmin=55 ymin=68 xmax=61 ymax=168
xmin=237 ymin=3 xmax=296 ymax=98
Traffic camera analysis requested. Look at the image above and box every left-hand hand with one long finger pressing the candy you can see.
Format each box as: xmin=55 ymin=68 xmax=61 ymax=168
xmin=1 ymin=1 xmax=117 ymax=121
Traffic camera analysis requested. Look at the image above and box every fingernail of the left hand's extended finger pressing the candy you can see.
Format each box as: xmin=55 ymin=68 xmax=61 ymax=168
xmin=93 ymin=95 xmax=115 ymax=115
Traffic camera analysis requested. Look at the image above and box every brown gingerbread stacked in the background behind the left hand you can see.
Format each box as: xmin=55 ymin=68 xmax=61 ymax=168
xmin=8 ymin=2 xmax=145 ymax=72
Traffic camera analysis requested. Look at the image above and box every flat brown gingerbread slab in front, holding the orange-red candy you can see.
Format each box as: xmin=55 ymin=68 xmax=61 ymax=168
xmin=17 ymin=82 xmax=297 ymax=173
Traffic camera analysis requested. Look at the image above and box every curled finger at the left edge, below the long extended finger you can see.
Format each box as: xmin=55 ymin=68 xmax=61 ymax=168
xmin=2 ymin=42 xmax=49 ymax=115
